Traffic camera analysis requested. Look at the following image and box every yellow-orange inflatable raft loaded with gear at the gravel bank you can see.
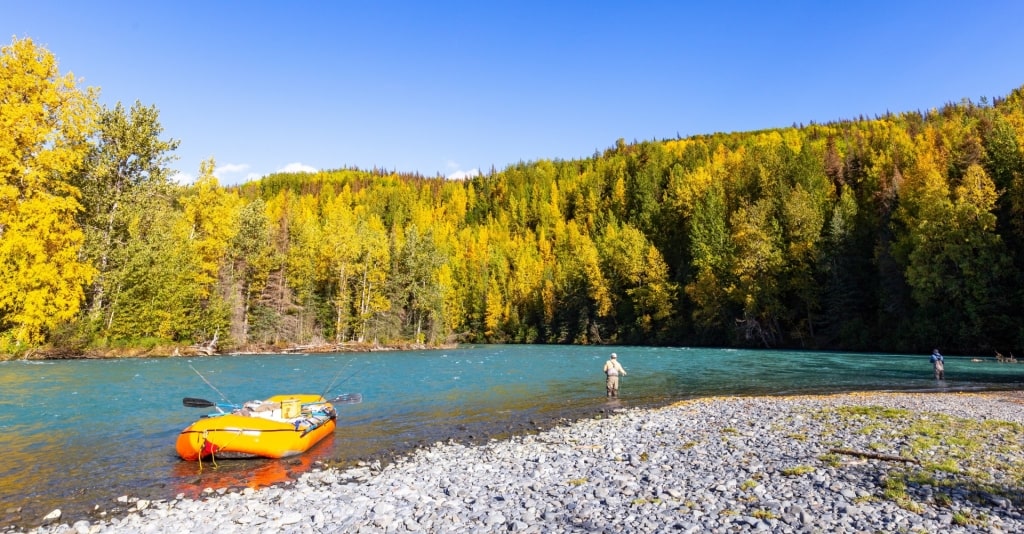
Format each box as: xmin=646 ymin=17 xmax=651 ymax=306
xmin=175 ymin=395 xmax=337 ymax=461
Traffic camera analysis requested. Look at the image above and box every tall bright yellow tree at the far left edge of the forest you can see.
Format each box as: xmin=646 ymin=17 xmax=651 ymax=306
xmin=0 ymin=39 xmax=98 ymax=348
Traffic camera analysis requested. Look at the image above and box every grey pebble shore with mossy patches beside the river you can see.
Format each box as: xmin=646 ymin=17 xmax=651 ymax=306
xmin=19 ymin=393 xmax=1024 ymax=533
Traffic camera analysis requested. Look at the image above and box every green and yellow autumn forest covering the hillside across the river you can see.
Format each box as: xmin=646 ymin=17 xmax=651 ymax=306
xmin=0 ymin=38 xmax=1024 ymax=358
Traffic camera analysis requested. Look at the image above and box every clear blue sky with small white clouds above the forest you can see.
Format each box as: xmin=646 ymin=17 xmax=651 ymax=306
xmin=6 ymin=0 xmax=1024 ymax=184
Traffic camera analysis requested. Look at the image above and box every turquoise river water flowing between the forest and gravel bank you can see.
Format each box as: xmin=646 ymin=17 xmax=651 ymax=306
xmin=0 ymin=345 xmax=1024 ymax=528
